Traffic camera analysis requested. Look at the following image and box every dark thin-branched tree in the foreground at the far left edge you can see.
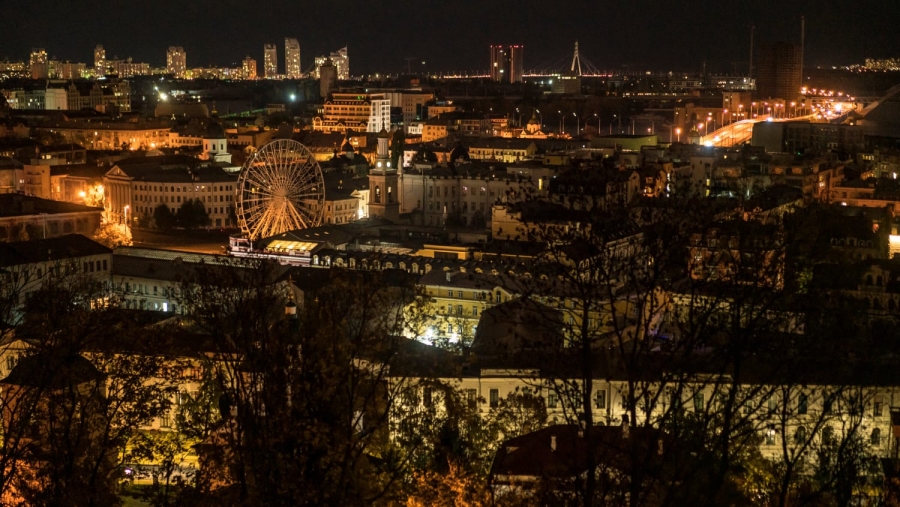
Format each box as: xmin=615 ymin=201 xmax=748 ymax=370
xmin=0 ymin=263 xmax=179 ymax=505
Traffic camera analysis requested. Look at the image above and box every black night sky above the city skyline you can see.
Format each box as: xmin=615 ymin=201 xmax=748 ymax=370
xmin=0 ymin=0 xmax=900 ymax=74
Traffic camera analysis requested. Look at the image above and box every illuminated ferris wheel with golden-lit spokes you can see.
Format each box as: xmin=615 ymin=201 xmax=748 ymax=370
xmin=236 ymin=139 xmax=325 ymax=239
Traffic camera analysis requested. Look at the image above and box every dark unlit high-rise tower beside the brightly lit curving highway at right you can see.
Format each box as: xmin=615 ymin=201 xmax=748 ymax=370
xmin=755 ymin=42 xmax=803 ymax=100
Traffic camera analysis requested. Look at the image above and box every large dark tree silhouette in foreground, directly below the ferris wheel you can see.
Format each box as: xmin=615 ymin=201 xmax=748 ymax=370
xmin=181 ymin=263 xmax=436 ymax=505
